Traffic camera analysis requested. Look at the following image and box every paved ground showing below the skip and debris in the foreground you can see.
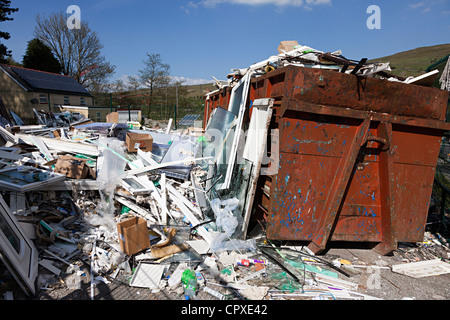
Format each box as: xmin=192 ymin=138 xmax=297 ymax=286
xmin=0 ymin=242 xmax=450 ymax=300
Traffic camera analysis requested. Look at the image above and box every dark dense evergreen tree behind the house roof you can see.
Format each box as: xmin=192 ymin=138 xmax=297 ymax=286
xmin=22 ymin=38 xmax=62 ymax=73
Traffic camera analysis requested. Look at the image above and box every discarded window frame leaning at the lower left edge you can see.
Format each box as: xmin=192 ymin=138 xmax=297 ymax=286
xmin=0 ymin=195 xmax=38 ymax=295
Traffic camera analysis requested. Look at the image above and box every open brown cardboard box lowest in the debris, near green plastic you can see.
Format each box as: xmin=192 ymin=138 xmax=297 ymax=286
xmin=117 ymin=217 xmax=150 ymax=256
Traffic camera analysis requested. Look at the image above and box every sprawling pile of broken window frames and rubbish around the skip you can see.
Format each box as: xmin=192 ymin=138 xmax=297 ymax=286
xmin=0 ymin=41 xmax=450 ymax=300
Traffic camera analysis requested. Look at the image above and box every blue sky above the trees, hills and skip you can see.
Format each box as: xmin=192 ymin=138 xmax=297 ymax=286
xmin=0 ymin=0 xmax=450 ymax=83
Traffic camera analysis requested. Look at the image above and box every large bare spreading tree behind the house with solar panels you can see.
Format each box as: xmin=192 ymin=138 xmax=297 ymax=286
xmin=34 ymin=12 xmax=116 ymax=88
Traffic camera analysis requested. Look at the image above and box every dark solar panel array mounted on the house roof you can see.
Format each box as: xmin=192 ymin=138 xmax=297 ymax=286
xmin=11 ymin=67 xmax=89 ymax=94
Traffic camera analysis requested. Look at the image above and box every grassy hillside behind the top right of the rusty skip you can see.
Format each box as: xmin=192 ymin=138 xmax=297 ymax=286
xmin=371 ymin=43 xmax=450 ymax=77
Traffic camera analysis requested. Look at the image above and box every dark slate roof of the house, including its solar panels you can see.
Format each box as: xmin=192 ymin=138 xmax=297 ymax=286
xmin=0 ymin=64 xmax=91 ymax=96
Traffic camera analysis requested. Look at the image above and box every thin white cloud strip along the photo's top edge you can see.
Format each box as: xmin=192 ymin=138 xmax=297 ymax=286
xmin=200 ymin=0 xmax=332 ymax=8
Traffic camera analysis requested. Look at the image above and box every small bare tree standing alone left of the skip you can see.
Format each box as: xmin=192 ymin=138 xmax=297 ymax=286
xmin=139 ymin=53 xmax=170 ymax=118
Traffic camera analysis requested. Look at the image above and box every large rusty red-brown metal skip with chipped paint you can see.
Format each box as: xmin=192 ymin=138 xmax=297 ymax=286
xmin=205 ymin=66 xmax=450 ymax=254
